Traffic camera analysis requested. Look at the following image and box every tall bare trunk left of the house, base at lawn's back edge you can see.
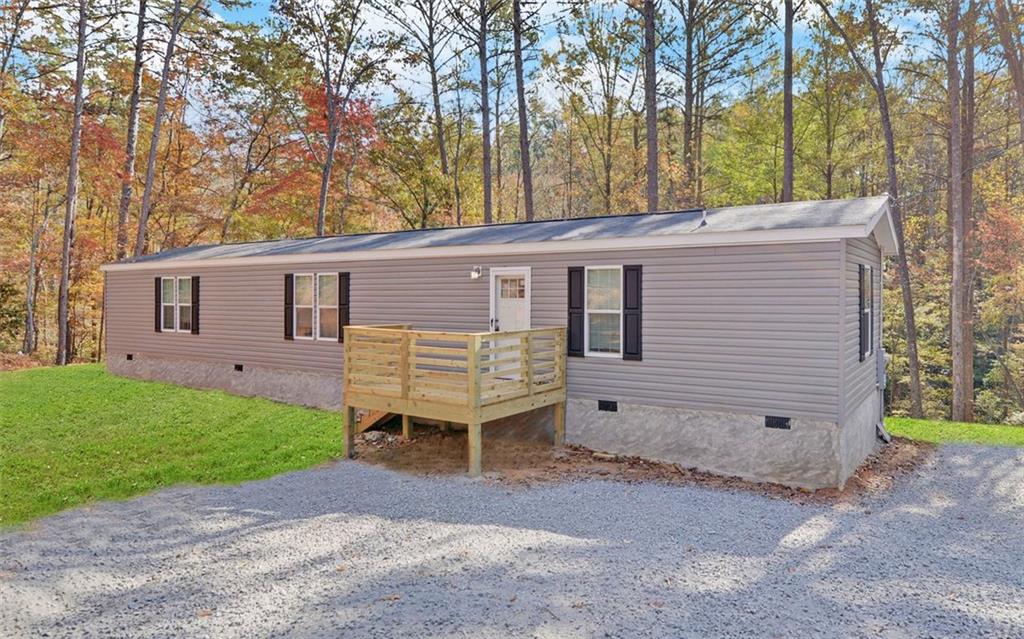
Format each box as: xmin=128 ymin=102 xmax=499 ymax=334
xmin=56 ymin=0 xmax=88 ymax=366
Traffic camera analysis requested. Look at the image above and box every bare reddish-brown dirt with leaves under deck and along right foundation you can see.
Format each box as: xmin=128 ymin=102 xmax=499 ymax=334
xmin=355 ymin=426 xmax=935 ymax=504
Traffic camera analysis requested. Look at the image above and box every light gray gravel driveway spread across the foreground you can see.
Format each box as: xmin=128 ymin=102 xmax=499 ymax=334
xmin=0 ymin=446 xmax=1024 ymax=638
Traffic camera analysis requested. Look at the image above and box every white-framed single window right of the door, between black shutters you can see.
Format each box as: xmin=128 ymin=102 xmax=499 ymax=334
xmin=584 ymin=266 xmax=623 ymax=357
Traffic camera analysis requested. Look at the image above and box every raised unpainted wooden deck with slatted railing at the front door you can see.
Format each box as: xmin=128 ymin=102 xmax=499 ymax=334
xmin=342 ymin=325 xmax=565 ymax=475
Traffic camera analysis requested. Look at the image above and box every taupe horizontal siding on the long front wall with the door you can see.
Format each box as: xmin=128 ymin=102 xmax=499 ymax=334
xmin=108 ymin=241 xmax=841 ymax=420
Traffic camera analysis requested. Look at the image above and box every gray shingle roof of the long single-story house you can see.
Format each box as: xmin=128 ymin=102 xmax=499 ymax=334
xmin=117 ymin=196 xmax=888 ymax=263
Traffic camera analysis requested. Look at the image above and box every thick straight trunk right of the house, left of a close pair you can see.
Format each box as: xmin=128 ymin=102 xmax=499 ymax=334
xmin=945 ymin=0 xmax=968 ymax=422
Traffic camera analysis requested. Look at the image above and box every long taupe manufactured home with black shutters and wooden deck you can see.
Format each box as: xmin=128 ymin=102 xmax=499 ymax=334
xmin=103 ymin=197 xmax=897 ymax=488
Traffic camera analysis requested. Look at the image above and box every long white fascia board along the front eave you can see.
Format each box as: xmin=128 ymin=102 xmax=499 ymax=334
xmin=99 ymin=224 xmax=870 ymax=272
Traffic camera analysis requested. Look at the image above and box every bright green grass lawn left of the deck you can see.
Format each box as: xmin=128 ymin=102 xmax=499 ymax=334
xmin=0 ymin=365 xmax=342 ymax=525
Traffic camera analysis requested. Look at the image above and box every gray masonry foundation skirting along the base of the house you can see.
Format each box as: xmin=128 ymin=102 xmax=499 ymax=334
xmin=106 ymin=353 xmax=879 ymax=488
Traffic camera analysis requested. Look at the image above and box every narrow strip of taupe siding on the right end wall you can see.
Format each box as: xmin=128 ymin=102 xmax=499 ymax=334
xmin=843 ymin=239 xmax=882 ymax=415
